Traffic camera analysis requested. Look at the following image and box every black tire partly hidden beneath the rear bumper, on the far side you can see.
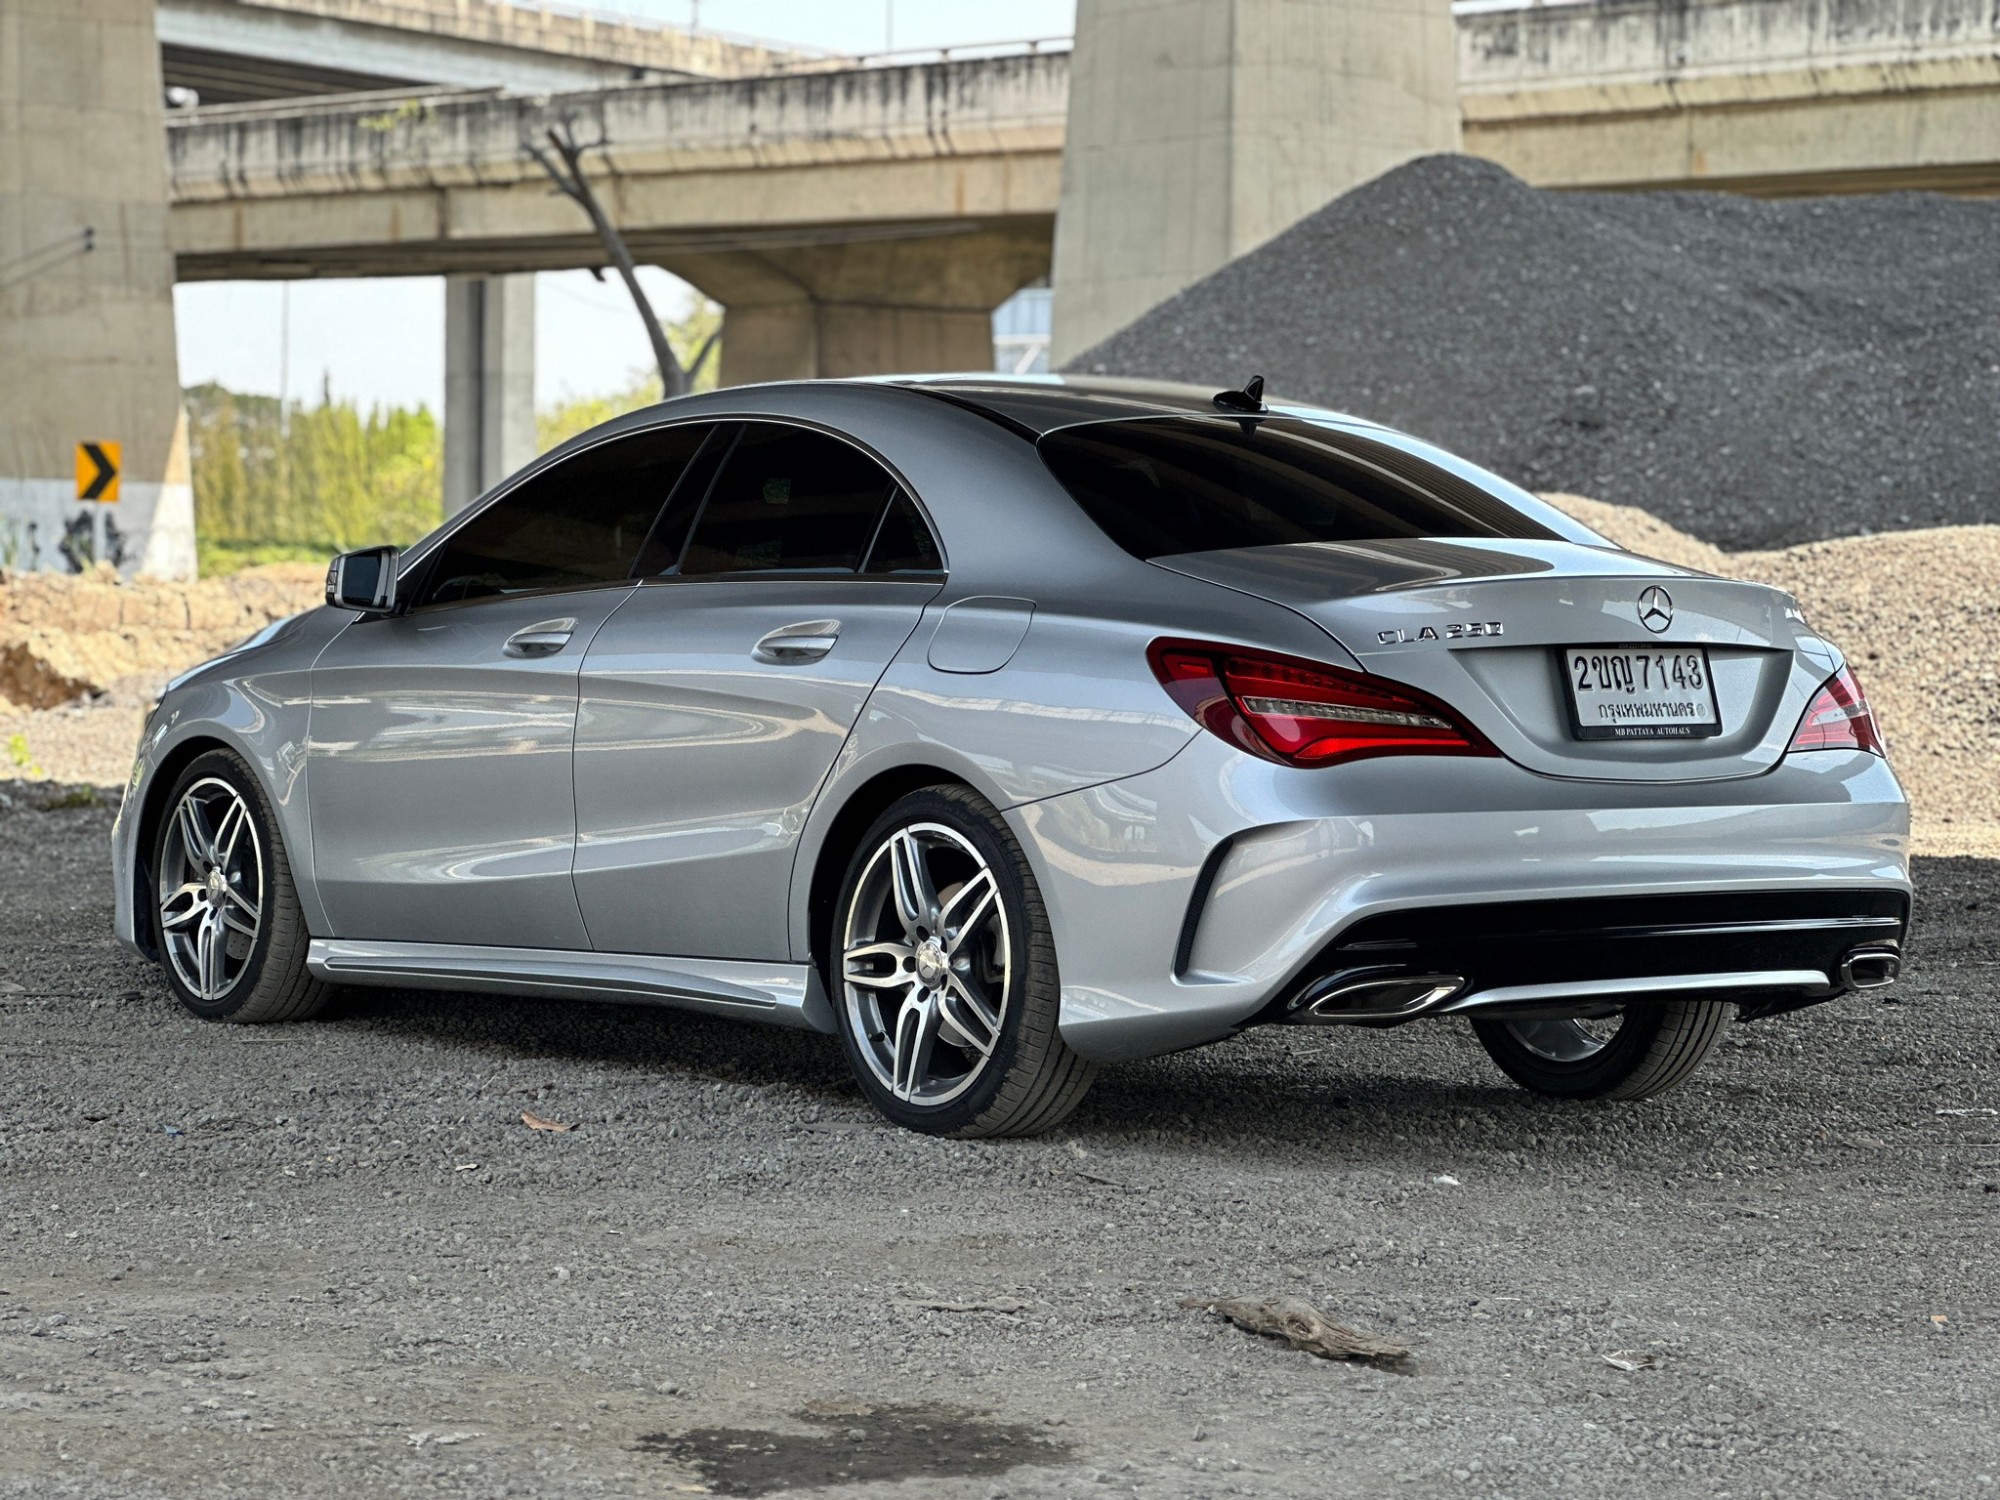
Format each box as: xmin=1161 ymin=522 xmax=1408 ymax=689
xmin=1472 ymin=1000 xmax=1734 ymax=1100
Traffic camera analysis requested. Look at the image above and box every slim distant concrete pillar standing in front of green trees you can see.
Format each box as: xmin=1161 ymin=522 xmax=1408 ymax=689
xmin=444 ymin=276 xmax=536 ymax=516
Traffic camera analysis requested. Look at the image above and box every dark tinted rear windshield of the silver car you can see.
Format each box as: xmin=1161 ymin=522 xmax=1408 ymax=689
xmin=1038 ymin=416 xmax=1556 ymax=558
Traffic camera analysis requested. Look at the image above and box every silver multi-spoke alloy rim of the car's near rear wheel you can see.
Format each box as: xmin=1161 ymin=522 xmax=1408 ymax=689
xmin=840 ymin=822 xmax=1014 ymax=1106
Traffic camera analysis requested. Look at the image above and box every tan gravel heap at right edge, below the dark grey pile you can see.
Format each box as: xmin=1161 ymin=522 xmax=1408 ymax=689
xmin=1544 ymin=494 xmax=2000 ymax=856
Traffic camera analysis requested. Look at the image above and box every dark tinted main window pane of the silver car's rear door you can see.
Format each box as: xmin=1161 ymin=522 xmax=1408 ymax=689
xmin=680 ymin=432 xmax=912 ymax=576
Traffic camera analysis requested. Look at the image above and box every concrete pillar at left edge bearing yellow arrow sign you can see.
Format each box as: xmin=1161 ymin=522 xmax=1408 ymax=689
xmin=0 ymin=0 xmax=194 ymax=578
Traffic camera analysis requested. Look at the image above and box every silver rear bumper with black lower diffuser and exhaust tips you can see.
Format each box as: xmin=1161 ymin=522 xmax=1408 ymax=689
xmin=1008 ymin=736 xmax=1910 ymax=1060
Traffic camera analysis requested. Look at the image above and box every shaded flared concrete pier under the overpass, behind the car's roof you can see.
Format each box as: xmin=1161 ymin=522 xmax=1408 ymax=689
xmin=668 ymin=220 xmax=1048 ymax=386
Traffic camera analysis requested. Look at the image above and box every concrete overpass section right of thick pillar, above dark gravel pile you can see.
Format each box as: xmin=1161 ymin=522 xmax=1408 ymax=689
xmin=1458 ymin=0 xmax=2000 ymax=196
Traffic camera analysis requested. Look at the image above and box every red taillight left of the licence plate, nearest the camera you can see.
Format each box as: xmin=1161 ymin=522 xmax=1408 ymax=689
xmin=1146 ymin=640 xmax=1498 ymax=766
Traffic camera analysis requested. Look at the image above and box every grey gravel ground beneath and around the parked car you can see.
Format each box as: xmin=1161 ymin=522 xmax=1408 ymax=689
xmin=0 ymin=806 xmax=2000 ymax=1500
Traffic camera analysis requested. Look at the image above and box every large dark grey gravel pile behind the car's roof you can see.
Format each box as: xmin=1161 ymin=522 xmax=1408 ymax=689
xmin=1070 ymin=156 xmax=2000 ymax=548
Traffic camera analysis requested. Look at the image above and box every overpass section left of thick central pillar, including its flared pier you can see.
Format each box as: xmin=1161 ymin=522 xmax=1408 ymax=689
xmin=168 ymin=54 xmax=1068 ymax=394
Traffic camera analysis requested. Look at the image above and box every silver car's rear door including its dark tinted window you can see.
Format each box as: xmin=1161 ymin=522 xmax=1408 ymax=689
xmin=576 ymin=422 xmax=944 ymax=962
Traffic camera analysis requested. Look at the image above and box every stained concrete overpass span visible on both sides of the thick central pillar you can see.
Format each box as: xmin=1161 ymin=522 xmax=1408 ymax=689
xmin=168 ymin=0 xmax=2000 ymax=288
